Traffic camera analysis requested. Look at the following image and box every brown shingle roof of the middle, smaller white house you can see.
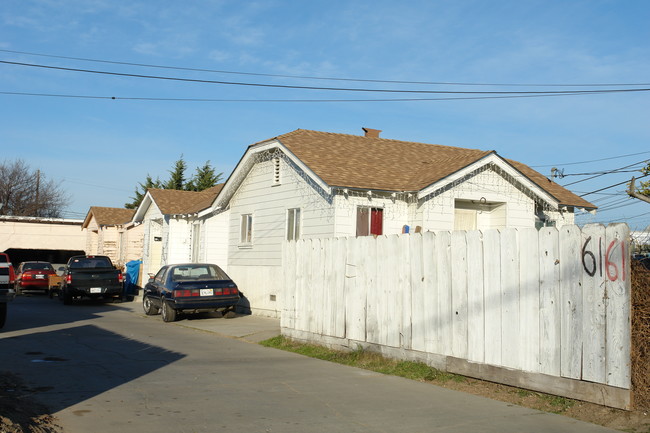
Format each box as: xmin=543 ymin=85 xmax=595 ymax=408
xmin=148 ymin=184 xmax=223 ymax=215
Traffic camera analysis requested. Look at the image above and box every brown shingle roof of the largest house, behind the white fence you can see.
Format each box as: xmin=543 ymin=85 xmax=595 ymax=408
xmin=276 ymin=129 xmax=595 ymax=208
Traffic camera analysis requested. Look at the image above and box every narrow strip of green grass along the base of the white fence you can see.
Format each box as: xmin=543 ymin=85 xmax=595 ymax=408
xmin=260 ymin=336 xmax=466 ymax=383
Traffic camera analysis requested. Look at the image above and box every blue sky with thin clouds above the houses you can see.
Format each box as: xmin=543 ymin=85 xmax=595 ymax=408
xmin=0 ymin=0 xmax=650 ymax=229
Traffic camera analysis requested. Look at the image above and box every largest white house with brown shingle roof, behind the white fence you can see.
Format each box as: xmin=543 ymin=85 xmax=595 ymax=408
xmin=200 ymin=128 xmax=596 ymax=316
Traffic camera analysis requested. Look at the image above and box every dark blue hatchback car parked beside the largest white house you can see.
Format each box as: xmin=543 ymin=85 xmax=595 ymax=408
xmin=142 ymin=263 xmax=240 ymax=322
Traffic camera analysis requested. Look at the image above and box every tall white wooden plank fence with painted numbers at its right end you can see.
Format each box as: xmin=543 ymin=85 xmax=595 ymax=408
xmin=281 ymin=224 xmax=630 ymax=406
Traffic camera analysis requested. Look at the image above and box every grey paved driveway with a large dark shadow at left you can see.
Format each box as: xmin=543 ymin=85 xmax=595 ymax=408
xmin=0 ymin=296 xmax=614 ymax=433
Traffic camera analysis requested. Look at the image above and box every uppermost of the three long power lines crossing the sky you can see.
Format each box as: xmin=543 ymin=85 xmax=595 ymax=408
xmin=0 ymin=49 xmax=650 ymax=87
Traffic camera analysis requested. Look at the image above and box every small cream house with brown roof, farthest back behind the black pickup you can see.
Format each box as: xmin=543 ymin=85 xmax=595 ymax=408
xmin=81 ymin=206 xmax=143 ymax=267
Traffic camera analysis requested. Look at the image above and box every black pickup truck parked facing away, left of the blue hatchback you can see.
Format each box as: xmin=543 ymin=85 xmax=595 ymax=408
xmin=59 ymin=256 xmax=124 ymax=305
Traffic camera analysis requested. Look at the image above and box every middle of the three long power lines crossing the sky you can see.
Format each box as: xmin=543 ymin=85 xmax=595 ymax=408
xmin=0 ymin=60 xmax=650 ymax=95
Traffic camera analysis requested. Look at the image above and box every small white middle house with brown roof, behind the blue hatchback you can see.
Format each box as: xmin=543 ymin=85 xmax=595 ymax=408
xmin=132 ymin=185 xmax=228 ymax=275
